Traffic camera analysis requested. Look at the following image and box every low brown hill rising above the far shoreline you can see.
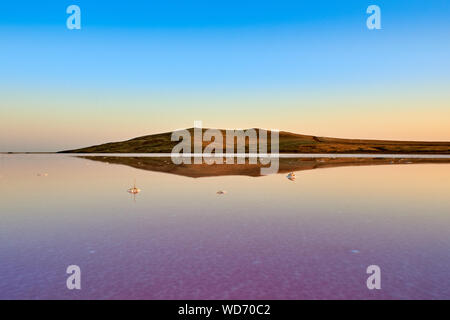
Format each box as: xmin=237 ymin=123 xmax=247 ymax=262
xmin=62 ymin=128 xmax=450 ymax=154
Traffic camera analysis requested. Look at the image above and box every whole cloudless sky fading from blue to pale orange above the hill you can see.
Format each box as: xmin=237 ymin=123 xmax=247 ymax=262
xmin=0 ymin=0 xmax=450 ymax=151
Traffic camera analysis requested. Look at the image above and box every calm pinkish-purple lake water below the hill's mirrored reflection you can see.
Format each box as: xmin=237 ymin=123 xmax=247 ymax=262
xmin=0 ymin=155 xmax=450 ymax=299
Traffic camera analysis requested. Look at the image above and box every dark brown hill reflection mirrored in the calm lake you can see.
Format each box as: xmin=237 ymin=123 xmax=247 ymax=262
xmin=80 ymin=156 xmax=450 ymax=178
